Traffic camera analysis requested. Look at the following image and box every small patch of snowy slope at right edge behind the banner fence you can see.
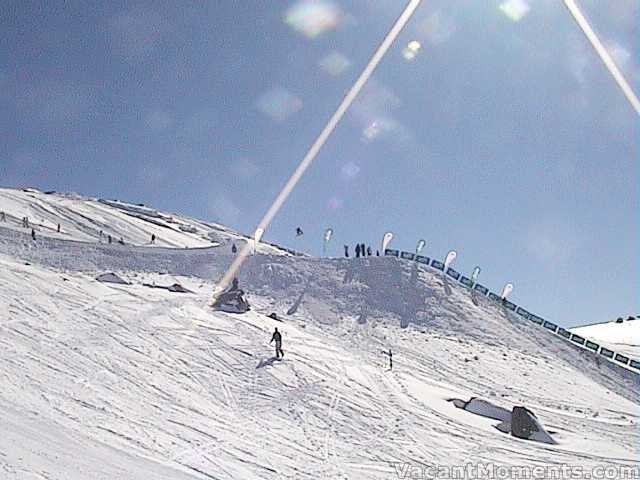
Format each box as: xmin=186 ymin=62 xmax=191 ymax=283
xmin=571 ymin=317 xmax=640 ymax=359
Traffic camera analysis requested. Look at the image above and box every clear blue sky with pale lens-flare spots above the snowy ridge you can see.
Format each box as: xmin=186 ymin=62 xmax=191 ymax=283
xmin=0 ymin=0 xmax=640 ymax=326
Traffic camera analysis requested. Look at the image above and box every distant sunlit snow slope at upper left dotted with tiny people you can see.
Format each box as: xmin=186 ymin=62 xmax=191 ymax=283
xmin=0 ymin=188 xmax=285 ymax=254
